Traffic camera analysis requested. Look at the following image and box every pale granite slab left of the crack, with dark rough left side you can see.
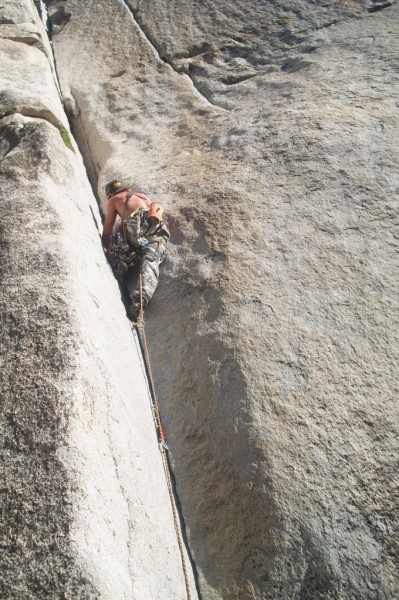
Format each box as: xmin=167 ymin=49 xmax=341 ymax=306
xmin=0 ymin=1 xmax=198 ymax=600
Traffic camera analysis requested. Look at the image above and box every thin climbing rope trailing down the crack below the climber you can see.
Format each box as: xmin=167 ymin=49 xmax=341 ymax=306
xmin=132 ymin=258 xmax=191 ymax=600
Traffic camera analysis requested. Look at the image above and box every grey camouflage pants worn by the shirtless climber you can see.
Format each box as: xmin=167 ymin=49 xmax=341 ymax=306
xmin=125 ymin=242 xmax=166 ymax=306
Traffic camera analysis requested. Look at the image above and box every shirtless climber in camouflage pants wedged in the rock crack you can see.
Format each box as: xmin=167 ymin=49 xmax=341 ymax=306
xmin=102 ymin=179 xmax=170 ymax=319
